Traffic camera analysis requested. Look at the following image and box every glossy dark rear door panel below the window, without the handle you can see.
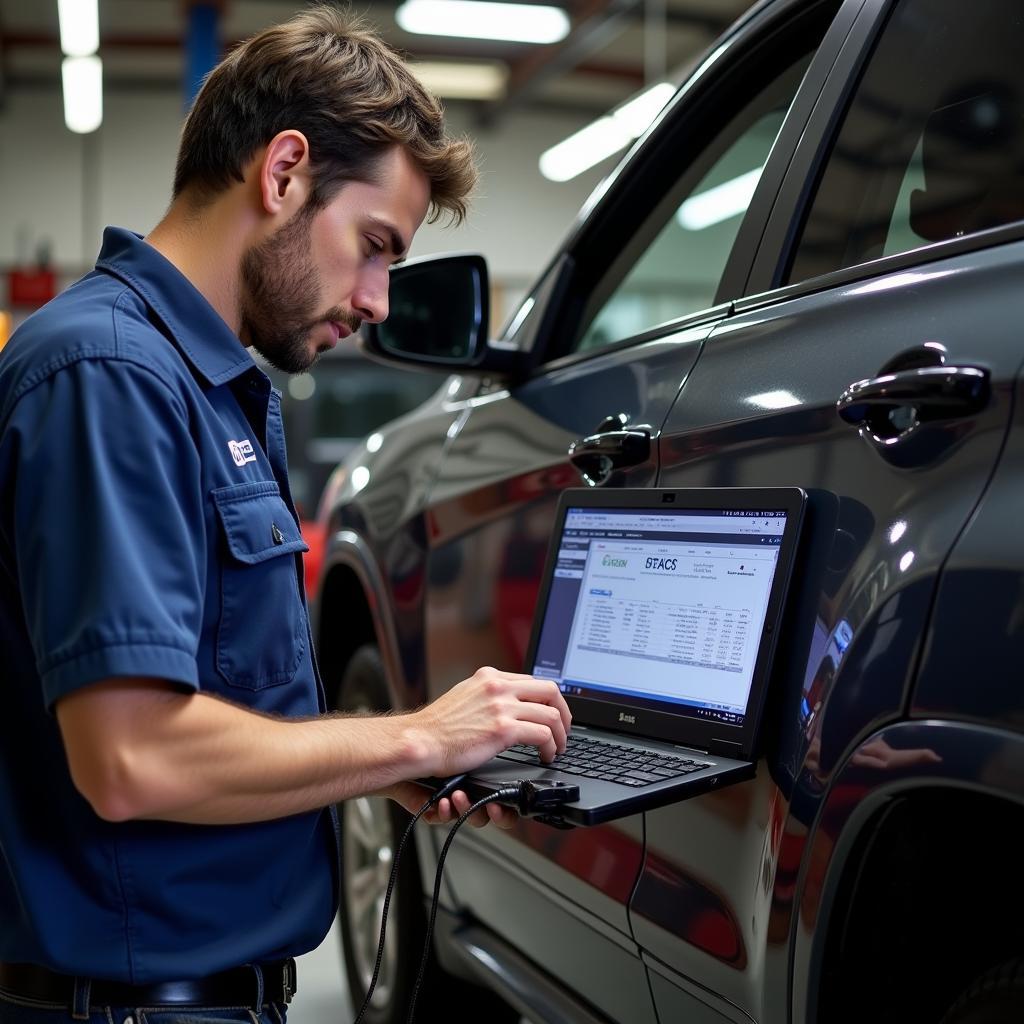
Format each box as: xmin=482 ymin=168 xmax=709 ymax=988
xmin=631 ymin=246 xmax=1024 ymax=1017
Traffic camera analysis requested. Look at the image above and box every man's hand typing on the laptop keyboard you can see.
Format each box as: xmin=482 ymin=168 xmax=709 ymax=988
xmin=411 ymin=669 xmax=572 ymax=778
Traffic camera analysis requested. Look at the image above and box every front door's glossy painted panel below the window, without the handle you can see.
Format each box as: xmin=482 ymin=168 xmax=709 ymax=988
xmin=415 ymin=324 xmax=712 ymax=983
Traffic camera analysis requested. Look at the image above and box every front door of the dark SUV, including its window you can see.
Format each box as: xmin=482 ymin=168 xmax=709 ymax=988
xmin=411 ymin=3 xmax=859 ymax=1024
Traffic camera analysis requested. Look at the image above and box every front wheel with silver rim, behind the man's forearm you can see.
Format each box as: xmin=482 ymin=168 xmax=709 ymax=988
xmin=336 ymin=644 xmax=519 ymax=1024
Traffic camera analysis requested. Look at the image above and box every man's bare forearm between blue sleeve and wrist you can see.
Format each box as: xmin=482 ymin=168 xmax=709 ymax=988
xmin=57 ymin=681 xmax=431 ymax=824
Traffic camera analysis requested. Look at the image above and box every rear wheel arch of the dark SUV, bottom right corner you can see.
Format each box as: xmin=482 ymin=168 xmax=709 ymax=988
xmin=791 ymin=721 xmax=1024 ymax=1024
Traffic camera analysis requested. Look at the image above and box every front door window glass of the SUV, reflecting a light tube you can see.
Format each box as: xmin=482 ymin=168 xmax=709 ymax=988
xmin=575 ymin=54 xmax=811 ymax=351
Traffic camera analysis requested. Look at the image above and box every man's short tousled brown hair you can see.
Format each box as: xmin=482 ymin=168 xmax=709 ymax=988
xmin=174 ymin=6 xmax=476 ymax=222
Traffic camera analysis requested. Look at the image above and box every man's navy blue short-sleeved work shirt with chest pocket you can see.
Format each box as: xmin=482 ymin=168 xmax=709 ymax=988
xmin=0 ymin=228 xmax=337 ymax=984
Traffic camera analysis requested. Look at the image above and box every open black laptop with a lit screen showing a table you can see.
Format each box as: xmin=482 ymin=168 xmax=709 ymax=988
xmin=432 ymin=487 xmax=806 ymax=826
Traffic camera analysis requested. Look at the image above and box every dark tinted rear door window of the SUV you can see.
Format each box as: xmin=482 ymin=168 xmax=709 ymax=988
xmin=786 ymin=0 xmax=1024 ymax=282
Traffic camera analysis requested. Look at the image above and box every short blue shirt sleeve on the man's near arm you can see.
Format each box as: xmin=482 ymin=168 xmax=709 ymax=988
xmin=8 ymin=358 xmax=206 ymax=707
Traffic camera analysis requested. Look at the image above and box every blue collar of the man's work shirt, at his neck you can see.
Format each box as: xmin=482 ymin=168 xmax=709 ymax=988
xmin=96 ymin=227 xmax=256 ymax=384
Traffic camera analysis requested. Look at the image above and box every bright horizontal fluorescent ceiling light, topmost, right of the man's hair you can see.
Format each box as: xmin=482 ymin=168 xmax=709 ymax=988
xmin=394 ymin=0 xmax=569 ymax=43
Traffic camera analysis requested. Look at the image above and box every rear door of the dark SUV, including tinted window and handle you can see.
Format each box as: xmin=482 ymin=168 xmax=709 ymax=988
xmin=631 ymin=0 xmax=1024 ymax=1021
